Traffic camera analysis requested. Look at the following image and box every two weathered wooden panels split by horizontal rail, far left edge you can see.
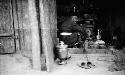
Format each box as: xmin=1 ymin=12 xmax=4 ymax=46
xmin=0 ymin=0 xmax=15 ymax=53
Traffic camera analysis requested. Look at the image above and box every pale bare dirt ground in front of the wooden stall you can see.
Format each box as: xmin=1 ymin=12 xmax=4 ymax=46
xmin=0 ymin=49 xmax=125 ymax=75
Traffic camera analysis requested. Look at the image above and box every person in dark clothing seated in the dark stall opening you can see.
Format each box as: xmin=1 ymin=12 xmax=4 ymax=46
xmin=60 ymin=16 xmax=84 ymax=46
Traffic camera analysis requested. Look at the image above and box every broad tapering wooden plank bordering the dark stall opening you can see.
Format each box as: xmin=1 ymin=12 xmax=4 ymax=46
xmin=39 ymin=0 xmax=57 ymax=72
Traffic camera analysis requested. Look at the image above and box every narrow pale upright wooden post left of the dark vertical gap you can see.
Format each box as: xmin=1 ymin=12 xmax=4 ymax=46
xmin=28 ymin=0 xmax=41 ymax=70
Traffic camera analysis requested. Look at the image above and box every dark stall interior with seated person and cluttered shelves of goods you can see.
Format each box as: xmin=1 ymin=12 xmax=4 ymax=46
xmin=57 ymin=0 xmax=124 ymax=48
